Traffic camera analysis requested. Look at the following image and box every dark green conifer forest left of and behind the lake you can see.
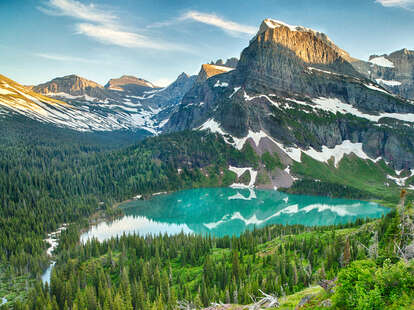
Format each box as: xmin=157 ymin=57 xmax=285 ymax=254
xmin=0 ymin=121 xmax=256 ymax=298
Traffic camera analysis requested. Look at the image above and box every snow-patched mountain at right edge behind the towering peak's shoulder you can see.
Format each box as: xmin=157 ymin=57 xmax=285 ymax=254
xmin=354 ymin=48 xmax=414 ymax=100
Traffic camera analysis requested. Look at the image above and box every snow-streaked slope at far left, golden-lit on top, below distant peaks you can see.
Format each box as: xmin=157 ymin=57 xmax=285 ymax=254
xmin=0 ymin=78 xmax=170 ymax=134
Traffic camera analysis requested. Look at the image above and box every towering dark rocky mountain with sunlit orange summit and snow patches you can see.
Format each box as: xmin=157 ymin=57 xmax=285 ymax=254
xmin=164 ymin=20 xmax=414 ymax=169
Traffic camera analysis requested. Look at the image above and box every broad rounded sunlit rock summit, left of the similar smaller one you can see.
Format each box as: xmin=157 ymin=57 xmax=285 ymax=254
xmin=32 ymin=74 xmax=107 ymax=99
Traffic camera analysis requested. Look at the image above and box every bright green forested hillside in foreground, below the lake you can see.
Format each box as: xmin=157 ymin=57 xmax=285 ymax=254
xmin=9 ymin=209 xmax=414 ymax=310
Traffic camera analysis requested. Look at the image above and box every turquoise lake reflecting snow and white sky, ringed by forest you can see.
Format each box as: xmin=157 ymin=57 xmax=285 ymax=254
xmin=81 ymin=188 xmax=389 ymax=242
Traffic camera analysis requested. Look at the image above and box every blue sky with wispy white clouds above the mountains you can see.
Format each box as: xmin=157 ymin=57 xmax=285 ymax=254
xmin=0 ymin=0 xmax=414 ymax=86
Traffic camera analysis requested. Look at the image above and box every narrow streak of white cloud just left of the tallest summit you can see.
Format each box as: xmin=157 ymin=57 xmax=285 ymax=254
xmin=179 ymin=11 xmax=257 ymax=35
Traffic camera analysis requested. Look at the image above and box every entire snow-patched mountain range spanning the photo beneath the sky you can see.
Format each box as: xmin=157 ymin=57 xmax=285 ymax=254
xmin=0 ymin=19 xmax=414 ymax=182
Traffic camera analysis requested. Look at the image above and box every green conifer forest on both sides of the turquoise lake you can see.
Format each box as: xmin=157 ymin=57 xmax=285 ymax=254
xmin=0 ymin=123 xmax=414 ymax=310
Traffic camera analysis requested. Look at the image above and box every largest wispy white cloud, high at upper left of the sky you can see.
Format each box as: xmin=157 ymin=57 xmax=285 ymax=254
xmin=39 ymin=0 xmax=186 ymax=50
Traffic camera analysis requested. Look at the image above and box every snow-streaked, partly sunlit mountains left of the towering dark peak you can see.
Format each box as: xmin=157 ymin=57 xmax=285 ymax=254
xmin=16 ymin=73 xmax=196 ymax=134
